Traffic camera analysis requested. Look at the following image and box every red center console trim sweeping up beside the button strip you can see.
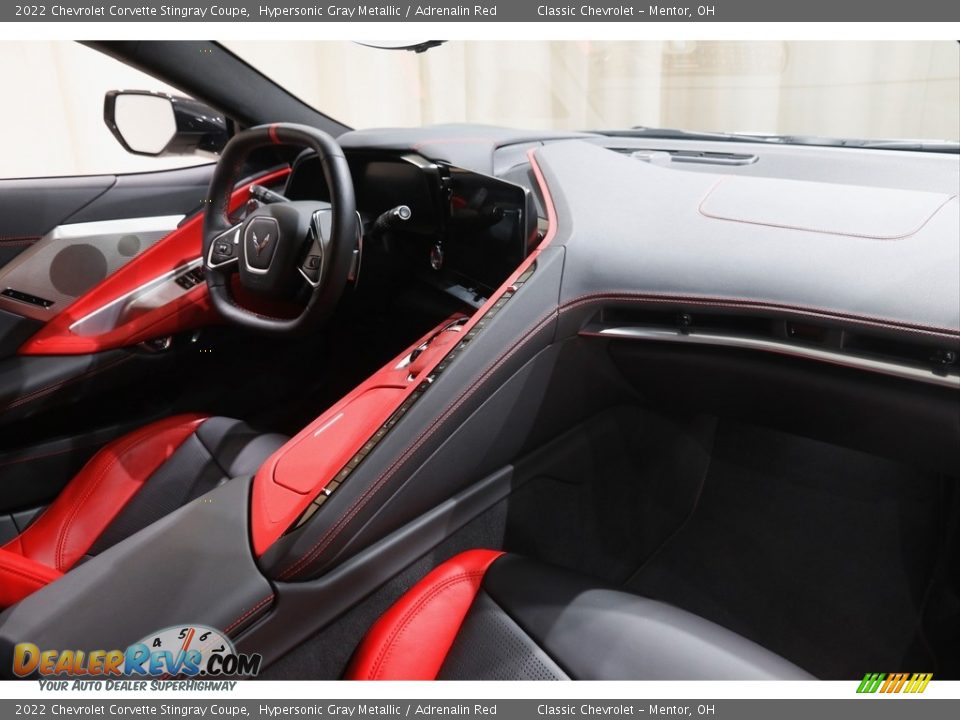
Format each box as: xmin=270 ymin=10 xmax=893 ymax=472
xmin=250 ymin=151 xmax=557 ymax=557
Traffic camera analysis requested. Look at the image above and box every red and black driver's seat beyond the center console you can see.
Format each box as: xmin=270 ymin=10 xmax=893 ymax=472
xmin=0 ymin=415 xmax=287 ymax=608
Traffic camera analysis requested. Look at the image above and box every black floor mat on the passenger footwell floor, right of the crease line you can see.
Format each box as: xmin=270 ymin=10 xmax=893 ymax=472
xmin=625 ymin=420 xmax=944 ymax=680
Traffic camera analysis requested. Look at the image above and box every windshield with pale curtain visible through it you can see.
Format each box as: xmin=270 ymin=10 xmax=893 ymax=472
xmin=225 ymin=40 xmax=960 ymax=141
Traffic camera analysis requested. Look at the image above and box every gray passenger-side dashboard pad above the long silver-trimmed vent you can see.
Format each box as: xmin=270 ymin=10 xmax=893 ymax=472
xmin=537 ymin=141 xmax=960 ymax=338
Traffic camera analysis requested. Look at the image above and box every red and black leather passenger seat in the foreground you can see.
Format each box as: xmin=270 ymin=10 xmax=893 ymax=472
xmin=347 ymin=550 xmax=811 ymax=680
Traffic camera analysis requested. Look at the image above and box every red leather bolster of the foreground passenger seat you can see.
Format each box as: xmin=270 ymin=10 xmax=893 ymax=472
xmin=346 ymin=550 xmax=503 ymax=680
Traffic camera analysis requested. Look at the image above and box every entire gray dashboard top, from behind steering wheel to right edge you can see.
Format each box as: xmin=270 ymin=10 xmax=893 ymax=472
xmin=339 ymin=125 xmax=960 ymax=343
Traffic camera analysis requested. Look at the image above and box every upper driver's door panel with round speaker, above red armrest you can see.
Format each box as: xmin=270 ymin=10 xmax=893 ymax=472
xmin=0 ymin=164 xmax=213 ymax=348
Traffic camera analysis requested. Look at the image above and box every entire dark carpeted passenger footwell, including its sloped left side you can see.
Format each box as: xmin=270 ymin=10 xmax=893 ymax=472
xmin=505 ymin=407 xmax=953 ymax=680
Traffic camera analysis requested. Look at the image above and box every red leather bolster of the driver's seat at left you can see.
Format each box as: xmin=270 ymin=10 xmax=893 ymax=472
xmin=0 ymin=415 xmax=206 ymax=572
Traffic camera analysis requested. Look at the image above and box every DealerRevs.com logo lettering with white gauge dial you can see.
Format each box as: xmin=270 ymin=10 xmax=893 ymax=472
xmin=13 ymin=625 xmax=263 ymax=680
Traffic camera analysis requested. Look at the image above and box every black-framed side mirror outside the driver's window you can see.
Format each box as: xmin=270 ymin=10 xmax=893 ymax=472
xmin=103 ymin=90 xmax=230 ymax=157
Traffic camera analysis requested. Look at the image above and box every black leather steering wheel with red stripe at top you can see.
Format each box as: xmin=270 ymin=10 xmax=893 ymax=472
xmin=203 ymin=123 xmax=360 ymax=335
